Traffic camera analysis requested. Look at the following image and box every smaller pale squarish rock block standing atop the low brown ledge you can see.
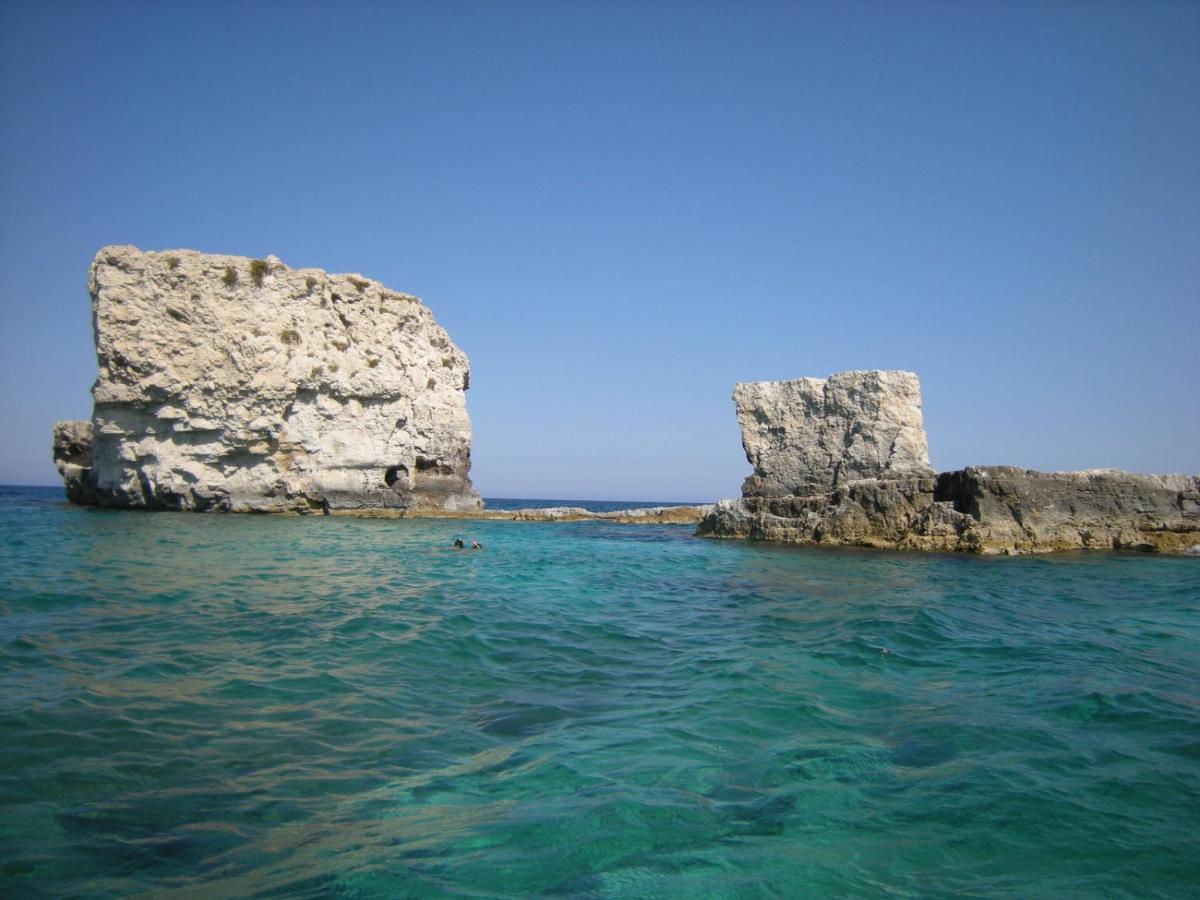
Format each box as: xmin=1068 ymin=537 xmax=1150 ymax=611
xmin=733 ymin=370 xmax=934 ymax=497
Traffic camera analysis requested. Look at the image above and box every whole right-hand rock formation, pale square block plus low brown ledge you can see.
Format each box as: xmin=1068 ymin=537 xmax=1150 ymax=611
xmin=700 ymin=371 xmax=1200 ymax=554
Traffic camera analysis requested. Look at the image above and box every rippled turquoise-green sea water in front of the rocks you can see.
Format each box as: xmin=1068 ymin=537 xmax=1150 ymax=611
xmin=0 ymin=488 xmax=1200 ymax=900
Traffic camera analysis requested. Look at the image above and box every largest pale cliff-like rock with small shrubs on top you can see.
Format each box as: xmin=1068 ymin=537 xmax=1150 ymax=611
xmin=56 ymin=246 xmax=481 ymax=511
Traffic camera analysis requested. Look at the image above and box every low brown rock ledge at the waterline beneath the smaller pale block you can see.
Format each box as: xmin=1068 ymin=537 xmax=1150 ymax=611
xmin=700 ymin=466 xmax=1200 ymax=554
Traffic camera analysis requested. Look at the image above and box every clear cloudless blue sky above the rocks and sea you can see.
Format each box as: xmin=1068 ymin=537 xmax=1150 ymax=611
xmin=0 ymin=0 xmax=1200 ymax=500
